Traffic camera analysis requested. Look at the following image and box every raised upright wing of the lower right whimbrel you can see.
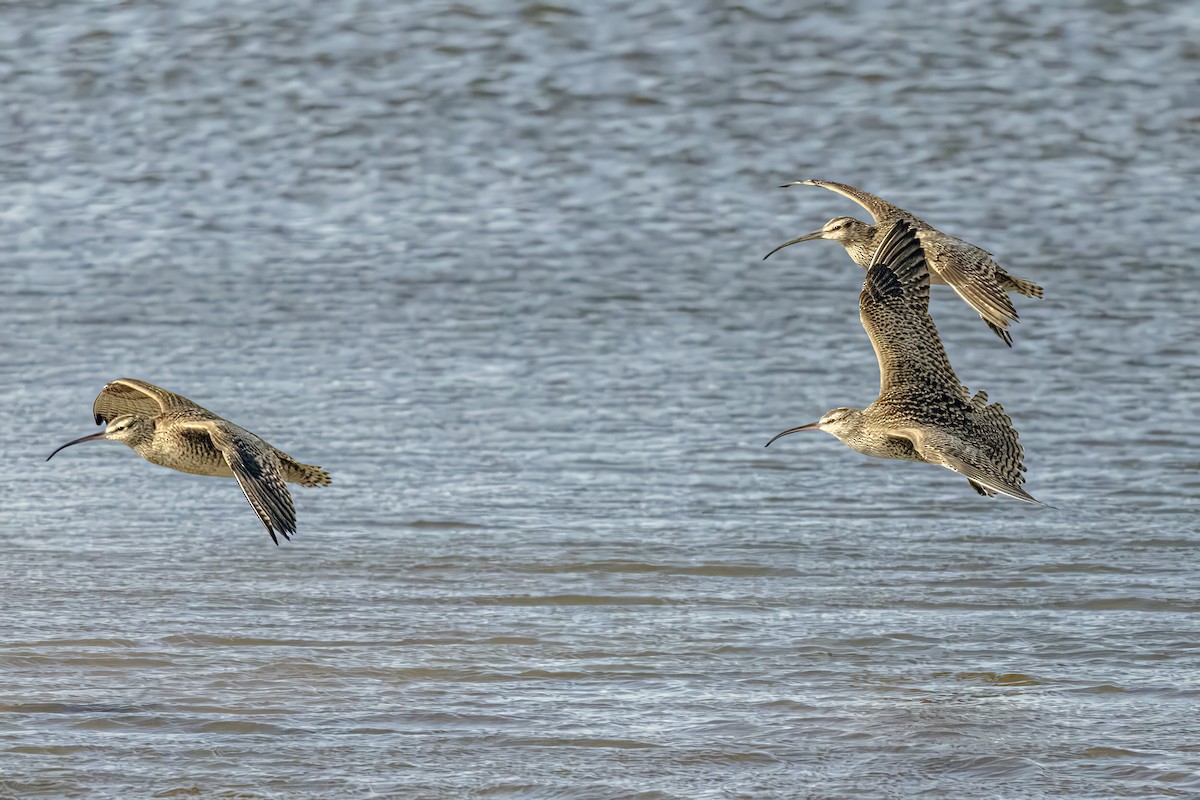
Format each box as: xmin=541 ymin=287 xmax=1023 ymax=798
xmin=858 ymin=219 xmax=962 ymax=397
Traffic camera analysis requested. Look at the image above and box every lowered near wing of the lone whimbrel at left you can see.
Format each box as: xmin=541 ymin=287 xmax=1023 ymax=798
xmin=180 ymin=420 xmax=296 ymax=545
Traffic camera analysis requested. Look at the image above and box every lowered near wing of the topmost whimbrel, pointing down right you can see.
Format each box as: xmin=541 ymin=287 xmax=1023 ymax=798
xmin=917 ymin=229 xmax=1016 ymax=347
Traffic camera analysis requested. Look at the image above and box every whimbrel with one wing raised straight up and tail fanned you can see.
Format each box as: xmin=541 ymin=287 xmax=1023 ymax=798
xmin=767 ymin=219 xmax=1040 ymax=505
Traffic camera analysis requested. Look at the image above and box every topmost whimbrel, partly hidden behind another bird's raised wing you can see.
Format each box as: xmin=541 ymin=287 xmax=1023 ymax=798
xmin=763 ymin=180 xmax=1042 ymax=347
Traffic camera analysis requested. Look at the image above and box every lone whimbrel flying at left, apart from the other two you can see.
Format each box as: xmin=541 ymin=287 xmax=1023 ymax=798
xmin=46 ymin=378 xmax=330 ymax=545
